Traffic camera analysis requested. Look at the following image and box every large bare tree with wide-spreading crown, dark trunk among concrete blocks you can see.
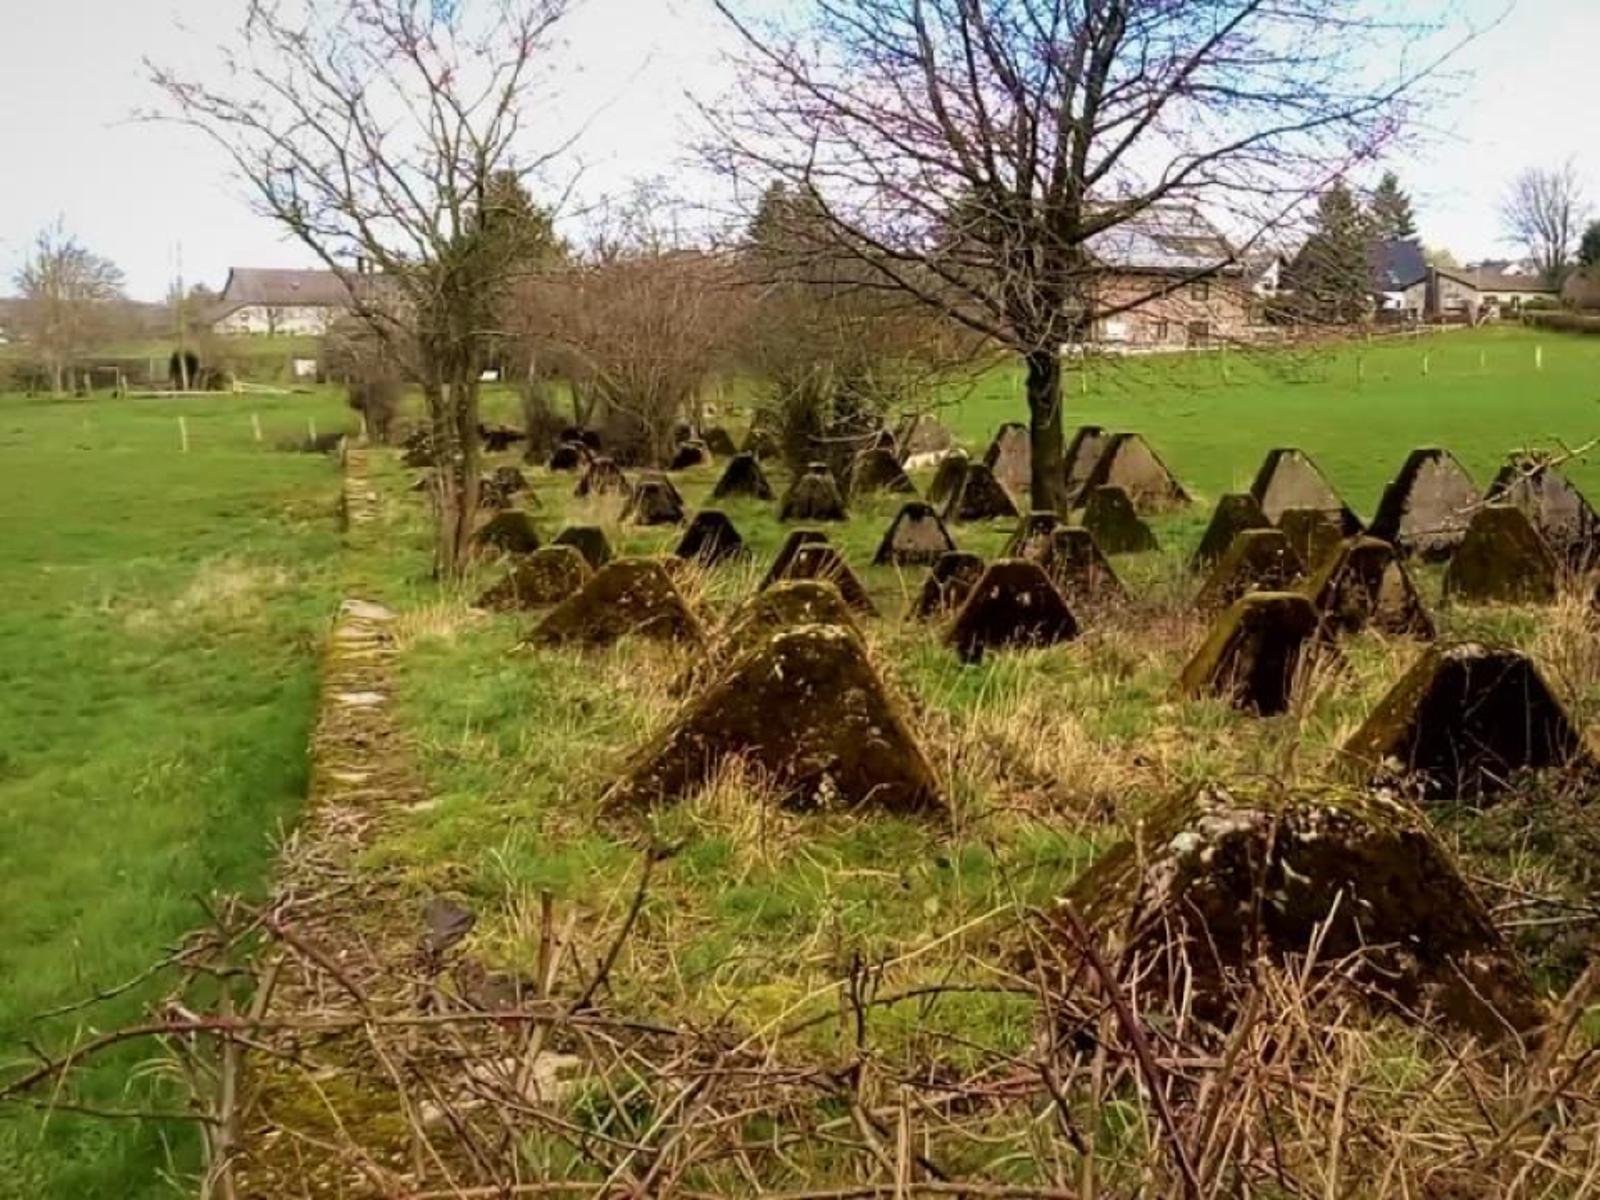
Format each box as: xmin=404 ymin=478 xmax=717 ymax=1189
xmin=704 ymin=0 xmax=1459 ymax=507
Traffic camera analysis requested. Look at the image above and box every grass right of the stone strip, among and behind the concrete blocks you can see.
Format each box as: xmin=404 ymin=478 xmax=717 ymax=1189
xmin=362 ymin=331 xmax=1600 ymax=1113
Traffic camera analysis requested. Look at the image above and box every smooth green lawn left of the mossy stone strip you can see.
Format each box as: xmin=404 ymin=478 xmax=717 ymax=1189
xmin=0 ymin=395 xmax=342 ymax=1200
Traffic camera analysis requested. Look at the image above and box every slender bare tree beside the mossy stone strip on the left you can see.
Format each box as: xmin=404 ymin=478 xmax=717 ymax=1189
xmin=150 ymin=0 xmax=566 ymax=576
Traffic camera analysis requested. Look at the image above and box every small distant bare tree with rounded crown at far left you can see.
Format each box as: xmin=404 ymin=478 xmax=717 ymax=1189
xmin=16 ymin=222 xmax=123 ymax=395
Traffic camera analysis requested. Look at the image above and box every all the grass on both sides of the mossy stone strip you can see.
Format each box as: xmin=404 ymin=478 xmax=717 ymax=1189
xmin=0 ymin=320 xmax=1600 ymax=1195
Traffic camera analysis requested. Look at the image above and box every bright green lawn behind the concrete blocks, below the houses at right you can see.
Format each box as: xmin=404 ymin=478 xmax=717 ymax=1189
xmin=947 ymin=328 xmax=1600 ymax=517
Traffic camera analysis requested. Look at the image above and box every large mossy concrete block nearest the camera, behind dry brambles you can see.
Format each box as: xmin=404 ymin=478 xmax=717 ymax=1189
xmin=1067 ymin=784 xmax=1546 ymax=1042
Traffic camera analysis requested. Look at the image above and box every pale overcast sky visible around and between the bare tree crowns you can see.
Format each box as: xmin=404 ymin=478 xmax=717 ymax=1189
xmin=0 ymin=0 xmax=1600 ymax=299
